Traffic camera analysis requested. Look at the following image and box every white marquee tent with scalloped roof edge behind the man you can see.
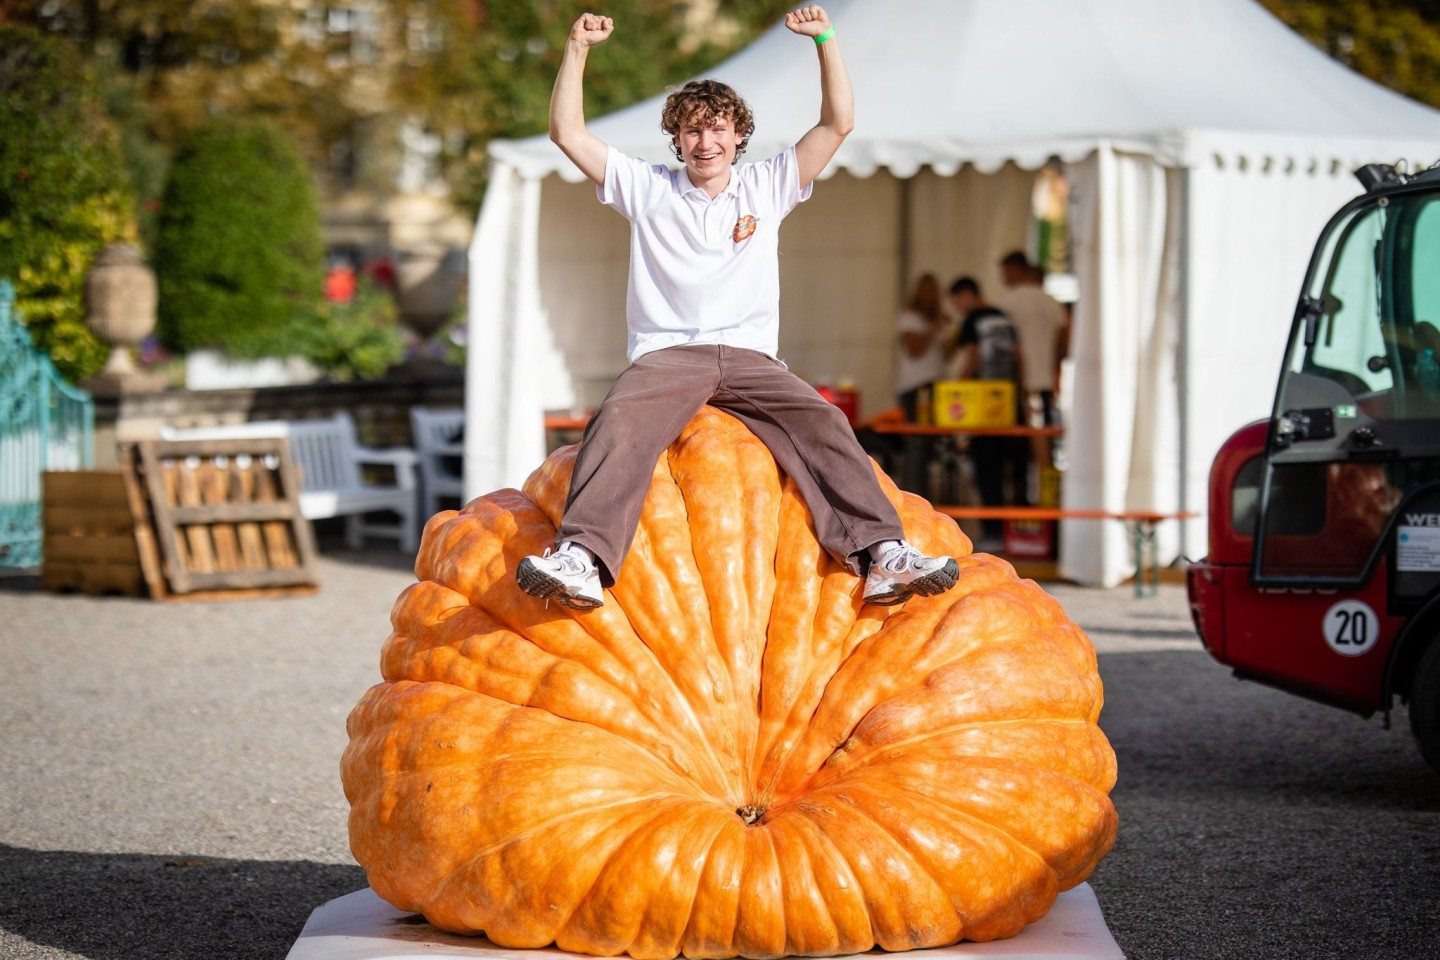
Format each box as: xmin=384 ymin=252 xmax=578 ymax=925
xmin=465 ymin=0 xmax=1440 ymax=584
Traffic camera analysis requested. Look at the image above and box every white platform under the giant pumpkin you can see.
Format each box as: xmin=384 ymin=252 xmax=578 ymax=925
xmin=287 ymin=884 xmax=1125 ymax=960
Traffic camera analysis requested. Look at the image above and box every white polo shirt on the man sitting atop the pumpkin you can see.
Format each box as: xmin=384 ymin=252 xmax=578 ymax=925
xmin=595 ymin=147 xmax=811 ymax=361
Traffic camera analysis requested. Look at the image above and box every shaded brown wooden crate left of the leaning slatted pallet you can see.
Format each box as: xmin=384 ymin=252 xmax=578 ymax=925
xmin=40 ymin=471 xmax=148 ymax=597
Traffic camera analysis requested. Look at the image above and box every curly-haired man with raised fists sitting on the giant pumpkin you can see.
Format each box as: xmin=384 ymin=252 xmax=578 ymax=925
xmin=516 ymin=6 xmax=959 ymax=610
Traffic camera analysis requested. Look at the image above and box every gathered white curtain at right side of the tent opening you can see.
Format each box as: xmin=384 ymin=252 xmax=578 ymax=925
xmin=1060 ymin=142 xmax=1182 ymax=586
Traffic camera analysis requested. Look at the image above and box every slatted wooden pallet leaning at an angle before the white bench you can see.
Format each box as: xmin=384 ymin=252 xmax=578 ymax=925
xmin=122 ymin=438 xmax=317 ymax=600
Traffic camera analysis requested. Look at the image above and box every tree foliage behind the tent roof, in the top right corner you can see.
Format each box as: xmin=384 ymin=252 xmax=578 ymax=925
xmin=1261 ymin=0 xmax=1440 ymax=108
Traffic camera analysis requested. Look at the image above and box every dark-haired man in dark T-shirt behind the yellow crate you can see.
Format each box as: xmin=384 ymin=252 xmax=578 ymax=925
xmin=950 ymin=276 xmax=1030 ymax=553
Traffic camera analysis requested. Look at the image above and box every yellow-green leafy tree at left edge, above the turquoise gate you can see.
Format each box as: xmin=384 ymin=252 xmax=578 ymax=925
xmin=0 ymin=24 xmax=135 ymax=380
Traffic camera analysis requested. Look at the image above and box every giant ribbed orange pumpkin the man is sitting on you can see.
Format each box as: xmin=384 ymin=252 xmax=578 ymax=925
xmin=341 ymin=409 xmax=1116 ymax=959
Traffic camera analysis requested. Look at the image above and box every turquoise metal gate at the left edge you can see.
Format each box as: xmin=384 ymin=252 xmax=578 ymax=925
xmin=0 ymin=279 xmax=95 ymax=567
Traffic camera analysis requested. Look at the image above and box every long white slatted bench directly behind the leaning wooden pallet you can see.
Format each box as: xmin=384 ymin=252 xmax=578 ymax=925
xmin=160 ymin=410 xmax=419 ymax=553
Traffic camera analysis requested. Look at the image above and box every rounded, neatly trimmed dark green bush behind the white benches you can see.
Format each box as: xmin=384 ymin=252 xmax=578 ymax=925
xmin=154 ymin=118 xmax=324 ymax=357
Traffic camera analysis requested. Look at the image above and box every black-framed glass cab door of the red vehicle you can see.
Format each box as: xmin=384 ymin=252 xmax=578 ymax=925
xmin=1253 ymin=187 xmax=1440 ymax=584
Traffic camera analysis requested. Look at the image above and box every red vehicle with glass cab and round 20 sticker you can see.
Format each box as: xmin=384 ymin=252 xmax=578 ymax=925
xmin=1187 ymin=164 xmax=1440 ymax=770
